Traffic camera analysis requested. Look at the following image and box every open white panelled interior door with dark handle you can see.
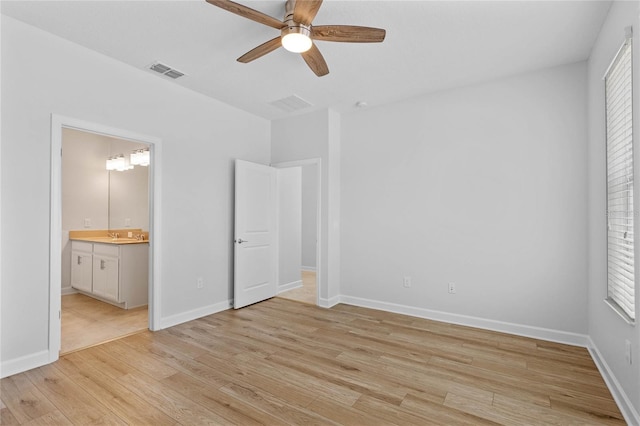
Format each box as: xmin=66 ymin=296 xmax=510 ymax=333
xmin=233 ymin=160 xmax=278 ymax=309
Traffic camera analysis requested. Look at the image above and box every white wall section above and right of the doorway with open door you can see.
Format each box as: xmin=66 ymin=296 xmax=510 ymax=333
xmin=271 ymin=110 xmax=341 ymax=307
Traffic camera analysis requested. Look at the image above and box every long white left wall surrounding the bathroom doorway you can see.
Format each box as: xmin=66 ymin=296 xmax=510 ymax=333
xmin=0 ymin=16 xmax=270 ymax=374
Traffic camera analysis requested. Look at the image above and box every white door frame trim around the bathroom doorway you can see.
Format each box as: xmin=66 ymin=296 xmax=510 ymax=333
xmin=48 ymin=114 xmax=162 ymax=362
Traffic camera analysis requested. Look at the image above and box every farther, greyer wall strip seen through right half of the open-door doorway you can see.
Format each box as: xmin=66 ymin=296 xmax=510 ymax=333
xmin=302 ymin=164 xmax=318 ymax=271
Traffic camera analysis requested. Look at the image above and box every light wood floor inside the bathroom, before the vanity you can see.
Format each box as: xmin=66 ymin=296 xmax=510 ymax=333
xmin=60 ymin=293 xmax=149 ymax=354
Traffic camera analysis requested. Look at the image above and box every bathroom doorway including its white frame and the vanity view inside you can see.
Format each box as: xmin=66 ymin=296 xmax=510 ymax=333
xmin=49 ymin=115 xmax=161 ymax=361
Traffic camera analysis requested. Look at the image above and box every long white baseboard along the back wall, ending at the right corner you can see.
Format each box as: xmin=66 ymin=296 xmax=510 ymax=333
xmin=340 ymin=296 xmax=588 ymax=347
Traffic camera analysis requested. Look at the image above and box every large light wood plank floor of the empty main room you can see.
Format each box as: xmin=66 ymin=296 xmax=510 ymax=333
xmin=0 ymin=298 xmax=624 ymax=425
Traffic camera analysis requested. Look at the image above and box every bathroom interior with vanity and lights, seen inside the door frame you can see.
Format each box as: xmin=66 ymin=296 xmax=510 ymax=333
xmin=60 ymin=128 xmax=149 ymax=355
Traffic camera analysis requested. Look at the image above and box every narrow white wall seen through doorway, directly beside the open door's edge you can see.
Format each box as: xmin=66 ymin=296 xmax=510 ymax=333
xmin=278 ymin=167 xmax=302 ymax=292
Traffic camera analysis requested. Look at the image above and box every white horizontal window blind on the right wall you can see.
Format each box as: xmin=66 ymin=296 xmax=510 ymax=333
xmin=604 ymin=37 xmax=635 ymax=320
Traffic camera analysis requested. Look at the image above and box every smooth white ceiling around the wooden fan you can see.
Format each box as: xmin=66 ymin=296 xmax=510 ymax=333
xmin=0 ymin=0 xmax=611 ymax=119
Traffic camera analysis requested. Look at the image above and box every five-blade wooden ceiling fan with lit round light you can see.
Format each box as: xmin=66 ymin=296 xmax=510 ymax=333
xmin=206 ymin=0 xmax=386 ymax=77
